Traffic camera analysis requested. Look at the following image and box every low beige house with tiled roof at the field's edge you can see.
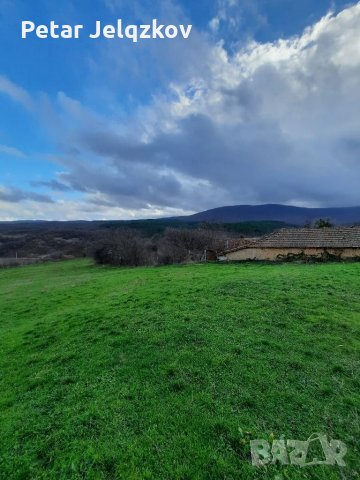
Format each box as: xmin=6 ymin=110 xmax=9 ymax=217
xmin=218 ymin=227 xmax=360 ymax=261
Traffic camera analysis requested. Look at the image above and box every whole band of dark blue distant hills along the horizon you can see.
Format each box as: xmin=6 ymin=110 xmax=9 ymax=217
xmin=0 ymin=204 xmax=360 ymax=236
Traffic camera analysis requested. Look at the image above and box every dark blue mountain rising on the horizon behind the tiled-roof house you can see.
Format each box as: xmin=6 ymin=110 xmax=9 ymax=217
xmin=181 ymin=204 xmax=360 ymax=225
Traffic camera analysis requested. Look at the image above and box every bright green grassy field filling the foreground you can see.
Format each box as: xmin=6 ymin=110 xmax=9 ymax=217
xmin=0 ymin=261 xmax=360 ymax=480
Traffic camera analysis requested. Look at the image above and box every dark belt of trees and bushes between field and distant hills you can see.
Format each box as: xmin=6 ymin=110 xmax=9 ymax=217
xmin=0 ymin=219 xmax=338 ymax=266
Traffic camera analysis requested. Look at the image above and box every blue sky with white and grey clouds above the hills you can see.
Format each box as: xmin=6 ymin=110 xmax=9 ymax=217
xmin=0 ymin=0 xmax=360 ymax=221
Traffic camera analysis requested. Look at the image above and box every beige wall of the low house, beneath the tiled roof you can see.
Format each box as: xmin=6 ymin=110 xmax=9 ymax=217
xmin=223 ymin=248 xmax=360 ymax=261
